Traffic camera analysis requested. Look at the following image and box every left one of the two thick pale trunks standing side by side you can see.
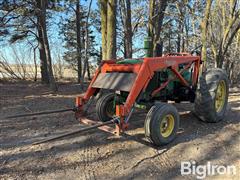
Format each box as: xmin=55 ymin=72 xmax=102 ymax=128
xmin=99 ymin=0 xmax=108 ymax=60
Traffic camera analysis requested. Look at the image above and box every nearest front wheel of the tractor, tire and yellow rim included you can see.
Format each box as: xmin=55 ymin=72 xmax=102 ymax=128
xmin=144 ymin=103 xmax=179 ymax=146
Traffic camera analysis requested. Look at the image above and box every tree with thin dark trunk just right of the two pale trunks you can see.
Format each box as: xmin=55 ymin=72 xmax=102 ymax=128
xmin=116 ymin=0 xmax=148 ymax=58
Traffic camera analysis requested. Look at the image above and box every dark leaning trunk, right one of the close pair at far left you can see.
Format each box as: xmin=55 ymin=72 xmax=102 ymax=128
xmin=37 ymin=0 xmax=57 ymax=91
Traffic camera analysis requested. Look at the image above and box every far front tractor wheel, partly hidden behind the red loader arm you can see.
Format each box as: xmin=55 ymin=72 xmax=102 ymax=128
xmin=96 ymin=93 xmax=115 ymax=122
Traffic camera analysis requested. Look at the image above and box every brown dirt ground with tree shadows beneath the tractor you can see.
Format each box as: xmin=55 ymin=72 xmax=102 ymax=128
xmin=0 ymin=83 xmax=240 ymax=179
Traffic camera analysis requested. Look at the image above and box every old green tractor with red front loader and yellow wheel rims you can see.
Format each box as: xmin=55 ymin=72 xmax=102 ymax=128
xmin=76 ymin=41 xmax=229 ymax=146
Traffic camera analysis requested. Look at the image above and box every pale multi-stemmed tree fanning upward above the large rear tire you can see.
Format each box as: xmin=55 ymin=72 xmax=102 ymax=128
xmin=210 ymin=0 xmax=240 ymax=69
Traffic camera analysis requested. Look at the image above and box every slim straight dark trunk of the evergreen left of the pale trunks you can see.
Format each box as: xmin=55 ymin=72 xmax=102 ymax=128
xmin=75 ymin=0 xmax=82 ymax=83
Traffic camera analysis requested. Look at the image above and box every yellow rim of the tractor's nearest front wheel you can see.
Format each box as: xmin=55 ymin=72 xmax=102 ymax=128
xmin=160 ymin=114 xmax=174 ymax=138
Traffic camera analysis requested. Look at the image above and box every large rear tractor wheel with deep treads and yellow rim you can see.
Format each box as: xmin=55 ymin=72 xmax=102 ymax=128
xmin=194 ymin=68 xmax=229 ymax=123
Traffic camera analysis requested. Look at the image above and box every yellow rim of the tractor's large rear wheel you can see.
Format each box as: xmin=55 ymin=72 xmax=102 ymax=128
xmin=215 ymin=80 xmax=226 ymax=113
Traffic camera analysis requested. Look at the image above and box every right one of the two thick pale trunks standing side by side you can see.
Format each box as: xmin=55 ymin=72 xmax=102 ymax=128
xmin=107 ymin=0 xmax=117 ymax=59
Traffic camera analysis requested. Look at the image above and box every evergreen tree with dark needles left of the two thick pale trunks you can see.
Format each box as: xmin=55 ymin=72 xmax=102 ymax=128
xmin=60 ymin=2 xmax=99 ymax=83
